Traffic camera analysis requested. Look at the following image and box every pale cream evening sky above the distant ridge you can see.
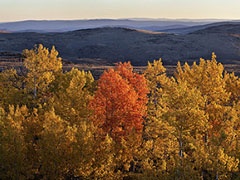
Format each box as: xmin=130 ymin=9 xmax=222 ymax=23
xmin=0 ymin=0 xmax=240 ymax=22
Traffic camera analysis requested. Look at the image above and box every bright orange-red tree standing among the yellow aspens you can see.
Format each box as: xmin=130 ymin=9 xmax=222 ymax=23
xmin=90 ymin=62 xmax=148 ymax=139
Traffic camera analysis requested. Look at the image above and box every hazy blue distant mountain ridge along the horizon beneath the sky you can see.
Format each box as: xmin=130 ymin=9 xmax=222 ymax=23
xmin=0 ymin=19 xmax=223 ymax=33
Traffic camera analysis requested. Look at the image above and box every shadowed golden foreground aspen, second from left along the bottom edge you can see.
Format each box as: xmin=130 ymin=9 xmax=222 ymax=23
xmin=37 ymin=111 xmax=77 ymax=179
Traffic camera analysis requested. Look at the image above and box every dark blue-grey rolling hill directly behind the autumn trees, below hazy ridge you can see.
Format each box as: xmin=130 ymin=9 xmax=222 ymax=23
xmin=0 ymin=23 xmax=240 ymax=65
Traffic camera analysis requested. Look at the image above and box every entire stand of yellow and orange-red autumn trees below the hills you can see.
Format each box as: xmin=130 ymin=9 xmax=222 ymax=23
xmin=0 ymin=45 xmax=240 ymax=180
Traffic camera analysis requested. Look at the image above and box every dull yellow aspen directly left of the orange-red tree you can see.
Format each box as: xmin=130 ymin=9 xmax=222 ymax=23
xmin=51 ymin=68 xmax=94 ymax=125
